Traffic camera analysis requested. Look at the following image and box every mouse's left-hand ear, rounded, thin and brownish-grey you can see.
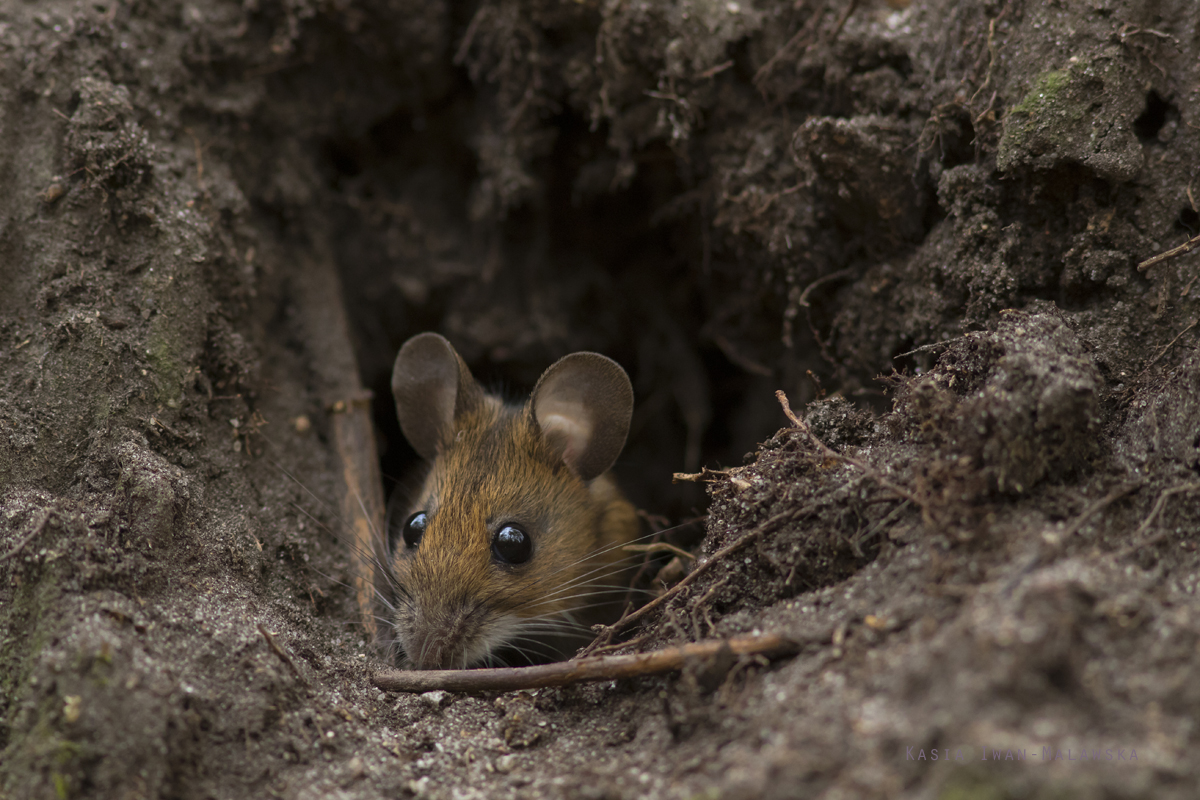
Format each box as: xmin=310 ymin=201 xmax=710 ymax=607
xmin=391 ymin=333 xmax=484 ymax=461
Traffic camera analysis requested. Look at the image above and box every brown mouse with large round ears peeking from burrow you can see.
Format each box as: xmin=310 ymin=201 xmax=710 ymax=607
xmin=388 ymin=332 xmax=638 ymax=669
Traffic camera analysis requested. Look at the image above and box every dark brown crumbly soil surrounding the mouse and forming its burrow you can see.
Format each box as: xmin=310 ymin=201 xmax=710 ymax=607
xmin=0 ymin=0 xmax=1200 ymax=800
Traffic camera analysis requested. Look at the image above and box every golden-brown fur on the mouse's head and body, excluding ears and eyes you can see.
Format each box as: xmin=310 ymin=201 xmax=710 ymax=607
xmin=391 ymin=374 xmax=637 ymax=668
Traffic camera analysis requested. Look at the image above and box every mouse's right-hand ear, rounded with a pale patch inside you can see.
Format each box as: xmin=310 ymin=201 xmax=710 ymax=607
xmin=529 ymin=353 xmax=634 ymax=481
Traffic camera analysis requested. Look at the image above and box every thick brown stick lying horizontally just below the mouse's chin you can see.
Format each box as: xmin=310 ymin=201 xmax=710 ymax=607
xmin=371 ymin=633 xmax=806 ymax=692
